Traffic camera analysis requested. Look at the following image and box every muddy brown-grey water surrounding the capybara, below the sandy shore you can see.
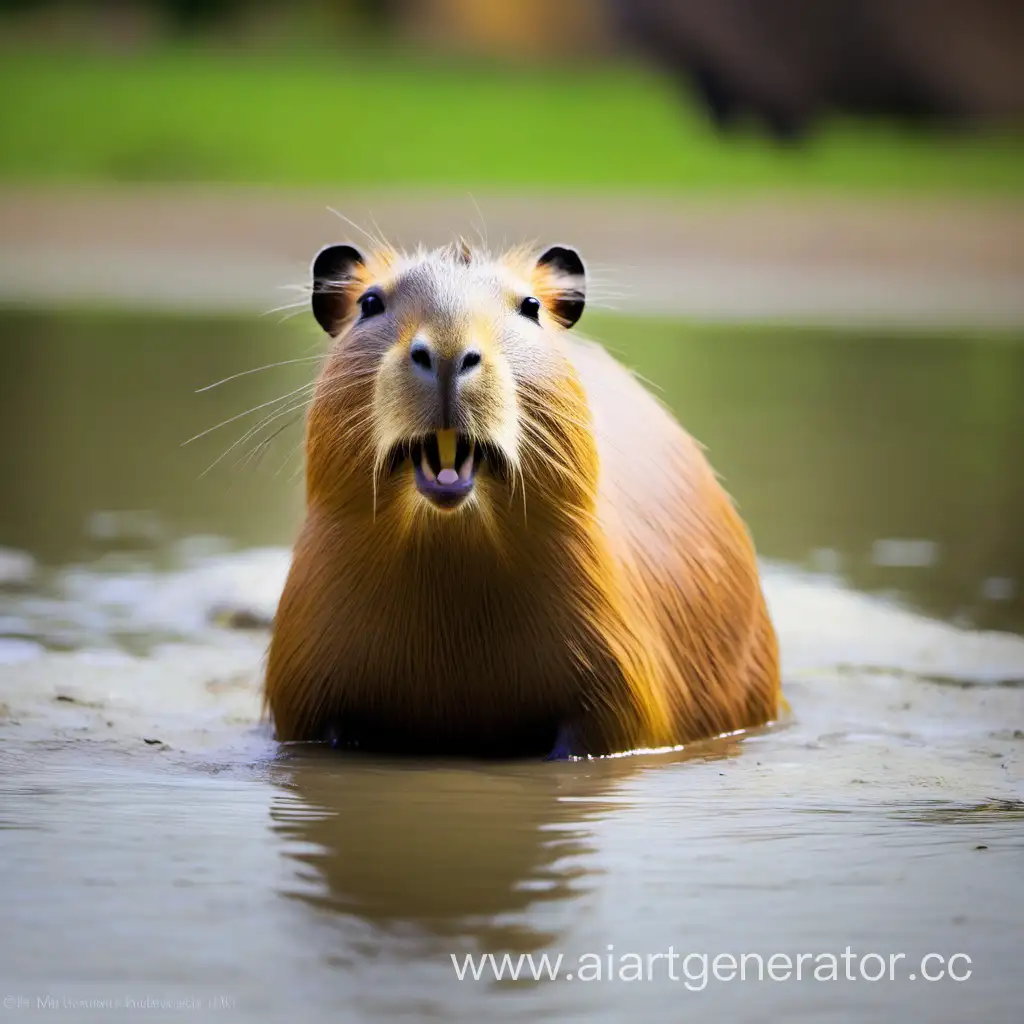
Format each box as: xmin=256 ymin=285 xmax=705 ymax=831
xmin=0 ymin=314 xmax=1024 ymax=1022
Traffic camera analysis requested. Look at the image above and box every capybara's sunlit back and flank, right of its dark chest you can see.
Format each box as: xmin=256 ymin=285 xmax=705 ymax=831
xmin=572 ymin=341 xmax=779 ymax=742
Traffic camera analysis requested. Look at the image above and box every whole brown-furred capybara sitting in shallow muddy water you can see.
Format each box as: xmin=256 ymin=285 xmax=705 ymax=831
xmin=266 ymin=235 xmax=780 ymax=756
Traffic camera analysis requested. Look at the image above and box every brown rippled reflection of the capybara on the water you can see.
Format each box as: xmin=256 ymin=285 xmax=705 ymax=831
xmin=270 ymin=751 xmax=622 ymax=952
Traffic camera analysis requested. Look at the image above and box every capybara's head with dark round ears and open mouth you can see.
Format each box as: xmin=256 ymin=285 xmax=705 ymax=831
xmin=306 ymin=241 xmax=596 ymax=527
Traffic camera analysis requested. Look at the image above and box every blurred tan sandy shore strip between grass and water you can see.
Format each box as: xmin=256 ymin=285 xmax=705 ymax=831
xmin=0 ymin=186 xmax=1024 ymax=327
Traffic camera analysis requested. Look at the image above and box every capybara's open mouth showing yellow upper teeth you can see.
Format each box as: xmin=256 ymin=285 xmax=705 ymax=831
xmin=388 ymin=430 xmax=507 ymax=509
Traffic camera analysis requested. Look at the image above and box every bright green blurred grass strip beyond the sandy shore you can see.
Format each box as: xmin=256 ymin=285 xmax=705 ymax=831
xmin=0 ymin=51 xmax=1024 ymax=194
